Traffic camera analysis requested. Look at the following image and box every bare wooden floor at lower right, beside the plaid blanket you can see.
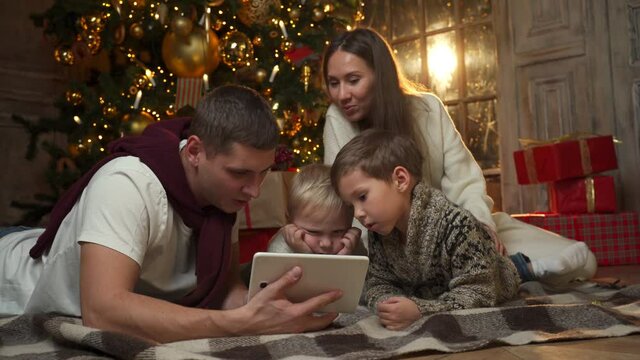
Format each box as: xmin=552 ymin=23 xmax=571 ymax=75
xmin=403 ymin=265 xmax=640 ymax=360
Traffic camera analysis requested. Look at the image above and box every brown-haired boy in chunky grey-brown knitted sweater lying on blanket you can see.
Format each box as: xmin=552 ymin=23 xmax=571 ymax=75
xmin=331 ymin=130 xmax=588 ymax=330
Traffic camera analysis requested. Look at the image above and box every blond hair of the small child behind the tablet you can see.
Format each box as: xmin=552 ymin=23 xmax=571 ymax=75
xmin=287 ymin=164 xmax=353 ymax=221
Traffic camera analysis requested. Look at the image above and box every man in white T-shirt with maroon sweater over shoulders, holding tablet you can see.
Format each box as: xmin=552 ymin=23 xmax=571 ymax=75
xmin=0 ymin=86 xmax=341 ymax=342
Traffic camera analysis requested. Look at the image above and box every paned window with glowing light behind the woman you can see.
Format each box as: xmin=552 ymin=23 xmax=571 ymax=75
xmin=364 ymin=0 xmax=500 ymax=172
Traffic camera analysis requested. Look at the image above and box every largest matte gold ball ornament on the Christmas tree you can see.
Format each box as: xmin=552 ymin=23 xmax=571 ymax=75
xmin=162 ymin=27 xmax=220 ymax=77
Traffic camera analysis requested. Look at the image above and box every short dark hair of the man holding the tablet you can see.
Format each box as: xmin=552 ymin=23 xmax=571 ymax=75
xmin=190 ymin=85 xmax=279 ymax=155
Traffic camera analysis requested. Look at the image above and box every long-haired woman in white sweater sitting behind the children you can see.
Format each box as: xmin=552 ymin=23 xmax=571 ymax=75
xmin=323 ymin=28 xmax=597 ymax=283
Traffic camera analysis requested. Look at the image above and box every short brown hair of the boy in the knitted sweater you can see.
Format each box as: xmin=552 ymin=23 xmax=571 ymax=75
xmin=331 ymin=129 xmax=423 ymax=189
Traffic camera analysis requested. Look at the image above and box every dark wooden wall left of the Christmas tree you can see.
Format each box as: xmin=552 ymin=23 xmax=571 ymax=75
xmin=0 ymin=0 xmax=65 ymax=226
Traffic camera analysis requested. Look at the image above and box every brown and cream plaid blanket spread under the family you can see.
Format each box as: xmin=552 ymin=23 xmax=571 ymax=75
xmin=0 ymin=282 xmax=640 ymax=359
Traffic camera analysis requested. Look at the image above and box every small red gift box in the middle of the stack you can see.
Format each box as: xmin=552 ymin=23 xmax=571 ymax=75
xmin=549 ymin=176 xmax=616 ymax=214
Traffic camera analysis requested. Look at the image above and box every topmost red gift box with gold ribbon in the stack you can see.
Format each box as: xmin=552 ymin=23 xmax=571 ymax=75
xmin=513 ymin=135 xmax=618 ymax=185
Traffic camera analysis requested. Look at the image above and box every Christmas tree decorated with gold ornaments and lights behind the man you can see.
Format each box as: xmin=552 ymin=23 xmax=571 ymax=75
xmin=13 ymin=0 xmax=363 ymax=223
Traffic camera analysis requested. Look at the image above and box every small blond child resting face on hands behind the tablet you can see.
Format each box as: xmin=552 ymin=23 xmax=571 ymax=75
xmin=268 ymin=164 xmax=367 ymax=255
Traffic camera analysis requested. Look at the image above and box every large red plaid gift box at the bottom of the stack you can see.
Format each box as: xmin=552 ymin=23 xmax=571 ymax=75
xmin=512 ymin=212 xmax=640 ymax=266
